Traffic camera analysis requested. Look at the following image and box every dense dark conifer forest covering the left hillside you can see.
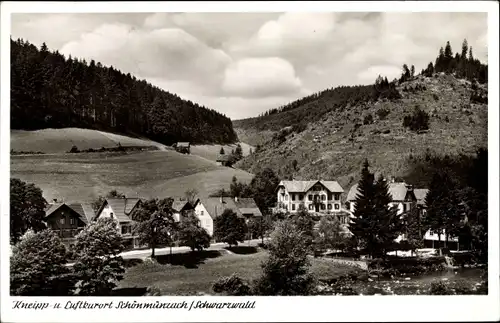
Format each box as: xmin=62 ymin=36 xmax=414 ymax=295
xmin=11 ymin=39 xmax=237 ymax=144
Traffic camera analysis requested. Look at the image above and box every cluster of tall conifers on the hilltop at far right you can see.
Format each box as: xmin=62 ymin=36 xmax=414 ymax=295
xmin=422 ymin=39 xmax=488 ymax=84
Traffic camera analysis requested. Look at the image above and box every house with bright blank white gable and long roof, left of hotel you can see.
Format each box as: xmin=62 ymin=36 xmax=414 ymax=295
xmin=194 ymin=197 xmax=262 ymax=236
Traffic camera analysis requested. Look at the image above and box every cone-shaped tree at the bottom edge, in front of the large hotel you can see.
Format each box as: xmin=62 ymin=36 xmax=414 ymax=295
xmin=255 ymin=220 xmax=314 ymax=296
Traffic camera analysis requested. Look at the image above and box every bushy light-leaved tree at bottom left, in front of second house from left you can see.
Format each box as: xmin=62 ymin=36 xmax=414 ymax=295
xmin=73 ymin=218 xmax=125 ymax=296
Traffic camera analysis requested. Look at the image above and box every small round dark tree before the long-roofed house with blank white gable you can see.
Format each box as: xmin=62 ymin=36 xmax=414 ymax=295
xmin=214 ymin=209 xmax=247 ymax=247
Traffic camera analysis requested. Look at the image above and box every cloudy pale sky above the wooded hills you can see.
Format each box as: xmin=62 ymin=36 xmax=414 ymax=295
xmin=11 ymin=12 xmax=488 ymax=120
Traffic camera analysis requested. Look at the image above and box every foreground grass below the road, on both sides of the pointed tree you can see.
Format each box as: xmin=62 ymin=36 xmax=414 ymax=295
xmin=119 ymin=249 xmax=356 ymax=295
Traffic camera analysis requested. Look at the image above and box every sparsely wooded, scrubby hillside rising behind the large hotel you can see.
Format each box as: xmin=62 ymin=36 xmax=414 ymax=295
xmin=236 ymin=73 xmax=488 ymax=189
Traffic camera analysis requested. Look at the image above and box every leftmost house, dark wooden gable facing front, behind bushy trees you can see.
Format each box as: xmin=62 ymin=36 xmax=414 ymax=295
xmin=45 ymin=200 xmax=94 ymax=247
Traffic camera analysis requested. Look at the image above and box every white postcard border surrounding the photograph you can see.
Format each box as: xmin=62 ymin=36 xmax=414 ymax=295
xmin=0 ymin=1 xmax=500 ymax=322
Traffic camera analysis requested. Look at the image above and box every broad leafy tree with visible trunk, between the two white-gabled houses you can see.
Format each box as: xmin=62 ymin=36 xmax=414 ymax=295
xmin=131 ymin=198 xmax=177 ymax=258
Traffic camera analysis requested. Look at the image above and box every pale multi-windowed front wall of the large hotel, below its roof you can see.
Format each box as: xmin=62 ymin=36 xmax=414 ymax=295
xmin=277 ymin=187 xmax=342 ymax=214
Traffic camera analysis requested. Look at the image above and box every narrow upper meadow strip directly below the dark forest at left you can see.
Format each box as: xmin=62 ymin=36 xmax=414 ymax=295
xmin=10 ymin=128 xmax=166 ymax=154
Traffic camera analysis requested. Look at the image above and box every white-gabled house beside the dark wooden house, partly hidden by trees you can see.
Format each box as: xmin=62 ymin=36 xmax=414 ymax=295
xmin=94 ymin=198 xmax=142 ymax=248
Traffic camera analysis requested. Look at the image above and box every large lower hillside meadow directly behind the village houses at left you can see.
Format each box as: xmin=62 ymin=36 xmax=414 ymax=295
xmin=11 ymin=151 xmax=252 ymax=202
